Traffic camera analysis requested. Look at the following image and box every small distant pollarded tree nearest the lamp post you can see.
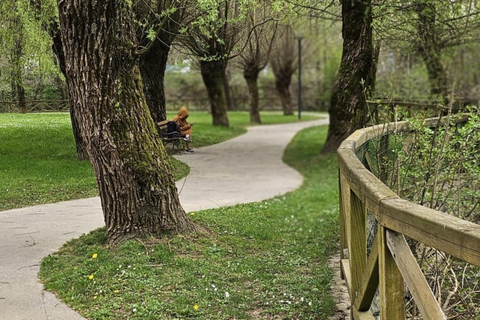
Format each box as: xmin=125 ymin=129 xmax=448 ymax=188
xmin=270 ymin=25 xmax=298 ymax=116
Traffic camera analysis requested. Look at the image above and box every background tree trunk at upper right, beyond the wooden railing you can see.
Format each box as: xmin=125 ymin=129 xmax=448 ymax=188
xmin=415 ymin=3 xmax=448 ymax=102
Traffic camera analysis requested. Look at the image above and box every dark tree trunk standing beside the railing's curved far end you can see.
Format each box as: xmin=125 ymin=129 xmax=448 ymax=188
xmin=322 ymin=0 xmax=373 ymax=153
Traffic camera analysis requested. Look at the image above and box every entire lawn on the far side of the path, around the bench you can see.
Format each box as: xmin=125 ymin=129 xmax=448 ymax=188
xmin=0 ymin=112 xmax=322 ymax=211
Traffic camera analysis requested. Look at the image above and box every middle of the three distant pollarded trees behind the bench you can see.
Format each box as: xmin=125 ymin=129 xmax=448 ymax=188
xmin=239 ymin=5 xmax=276 ymax=123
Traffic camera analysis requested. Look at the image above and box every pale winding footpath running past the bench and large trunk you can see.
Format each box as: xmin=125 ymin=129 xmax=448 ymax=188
xmin=0 ymin=119 xmax=328 ymax=320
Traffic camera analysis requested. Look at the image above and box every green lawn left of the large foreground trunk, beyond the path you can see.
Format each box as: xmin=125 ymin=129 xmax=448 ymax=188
xmin=0 ymin=114 xmax=97 ymax=210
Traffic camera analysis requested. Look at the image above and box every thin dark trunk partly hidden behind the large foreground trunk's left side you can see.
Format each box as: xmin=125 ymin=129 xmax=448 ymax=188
xmin=49 ymin=22 xmax=88 ymax=161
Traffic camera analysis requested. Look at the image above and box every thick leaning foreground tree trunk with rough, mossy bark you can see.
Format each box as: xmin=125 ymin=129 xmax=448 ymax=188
xmin=58 ymin=0 xmax=197 ymax=245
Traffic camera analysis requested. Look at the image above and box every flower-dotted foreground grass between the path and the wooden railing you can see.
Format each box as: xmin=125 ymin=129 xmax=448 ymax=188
xmin=40 ymin=125 xmax=338 ymax=320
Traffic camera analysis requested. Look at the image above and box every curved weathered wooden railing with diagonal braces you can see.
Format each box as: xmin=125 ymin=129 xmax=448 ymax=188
xmin=337 ymin=119 xmax=480 ymax=320
